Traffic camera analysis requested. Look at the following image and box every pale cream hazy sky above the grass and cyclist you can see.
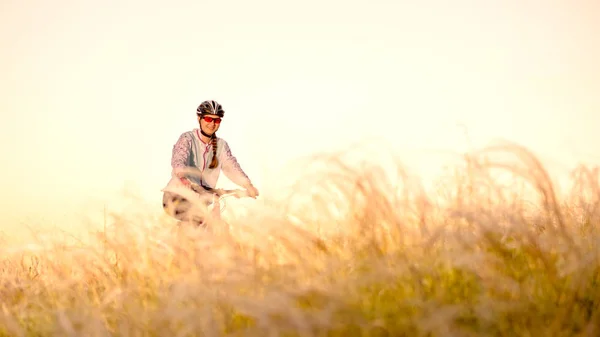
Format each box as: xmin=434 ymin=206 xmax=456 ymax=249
xmin=0 ymin=0 xmax=600 ymax=236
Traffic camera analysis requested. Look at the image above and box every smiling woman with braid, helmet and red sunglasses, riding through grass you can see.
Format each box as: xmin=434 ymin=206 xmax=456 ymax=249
xmin=163 ymin=100 xmax=258 ymax=225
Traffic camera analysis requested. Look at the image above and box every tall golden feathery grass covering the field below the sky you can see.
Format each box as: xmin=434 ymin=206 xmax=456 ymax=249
xmin=0 ymin=142 xmax=600 ymax=336
